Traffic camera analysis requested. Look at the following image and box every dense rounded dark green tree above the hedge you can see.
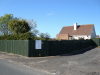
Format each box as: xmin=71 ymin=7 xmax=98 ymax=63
xmin=8 ymin=20 xmax=31 ymax=34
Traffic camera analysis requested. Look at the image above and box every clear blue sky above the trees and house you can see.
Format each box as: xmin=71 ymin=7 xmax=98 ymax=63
xmin=0 ymin=0 xmax=100 ymax=38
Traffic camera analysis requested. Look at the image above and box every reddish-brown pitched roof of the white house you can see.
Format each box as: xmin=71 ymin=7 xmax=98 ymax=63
xmin=59 ymin=24 xmax=94 ymax=35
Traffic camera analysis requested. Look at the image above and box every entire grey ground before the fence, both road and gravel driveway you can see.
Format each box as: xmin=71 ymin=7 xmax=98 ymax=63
xmin=0 ymin=48 xmax=100 ymax=75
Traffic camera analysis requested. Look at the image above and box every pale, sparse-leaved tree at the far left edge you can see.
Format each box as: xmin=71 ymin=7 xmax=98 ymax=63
xmin=0 ymin=14 xmax=14 ymax=35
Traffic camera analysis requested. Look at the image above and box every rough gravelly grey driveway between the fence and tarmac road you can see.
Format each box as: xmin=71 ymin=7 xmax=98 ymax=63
xmin=0 ymin=48 xmax=100 ymax=75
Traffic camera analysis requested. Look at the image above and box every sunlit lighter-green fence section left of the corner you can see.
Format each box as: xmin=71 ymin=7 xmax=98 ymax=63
xmin=0 ymin=40 xmax=29 ymax=56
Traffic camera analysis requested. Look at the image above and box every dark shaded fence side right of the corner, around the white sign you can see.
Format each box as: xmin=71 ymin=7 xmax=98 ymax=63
xmin=29 ymin=40 xmax=91 ymax=57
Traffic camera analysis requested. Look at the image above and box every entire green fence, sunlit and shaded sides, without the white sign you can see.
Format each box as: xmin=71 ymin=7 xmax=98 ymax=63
xmin=0 ymin=39 xmax=100 ymax=57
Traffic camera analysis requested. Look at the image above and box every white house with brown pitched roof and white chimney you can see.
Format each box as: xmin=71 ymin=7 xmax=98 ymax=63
xmin=56 ymin=23 xmax=96 ymax=40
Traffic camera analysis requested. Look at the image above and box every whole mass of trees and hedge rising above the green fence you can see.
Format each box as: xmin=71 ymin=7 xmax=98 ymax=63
xmin=0 ymin=14 xmax=50 ymax=40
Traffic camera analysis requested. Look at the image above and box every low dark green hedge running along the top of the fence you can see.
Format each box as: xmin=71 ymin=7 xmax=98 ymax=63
xmin=0 ymin=32 xmax=50 ymax=40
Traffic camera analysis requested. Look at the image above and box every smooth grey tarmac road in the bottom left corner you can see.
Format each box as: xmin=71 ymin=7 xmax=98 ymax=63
xmin=0 ymin=59 xmax=52 ymax=75
